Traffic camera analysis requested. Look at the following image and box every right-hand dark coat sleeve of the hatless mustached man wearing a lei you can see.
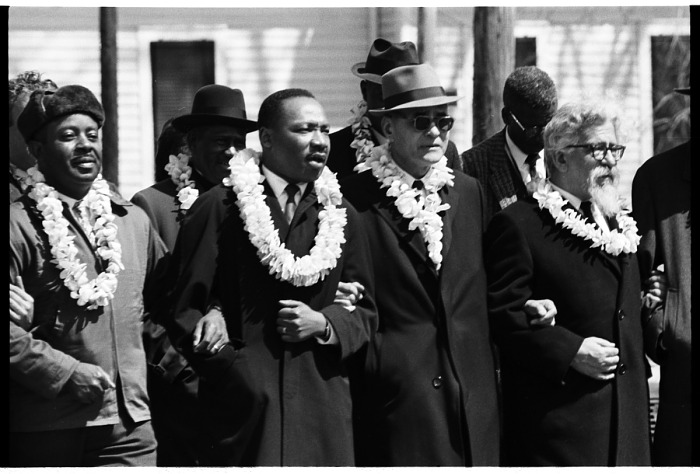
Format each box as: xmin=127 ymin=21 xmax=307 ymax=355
xmin=321 ymin=202 xmax=378 ymax=360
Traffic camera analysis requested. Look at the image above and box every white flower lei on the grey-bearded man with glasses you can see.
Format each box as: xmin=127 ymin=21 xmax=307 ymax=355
xmin=533 ymin=181 xmax=640 ymax=256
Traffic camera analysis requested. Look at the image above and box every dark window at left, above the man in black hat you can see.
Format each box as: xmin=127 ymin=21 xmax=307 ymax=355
xmin=151 ymin=41 xmax=214 ymax=181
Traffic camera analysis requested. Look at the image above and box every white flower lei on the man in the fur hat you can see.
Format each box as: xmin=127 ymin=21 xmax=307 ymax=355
xmin=29 ymin=168 xmax=124 ymax=310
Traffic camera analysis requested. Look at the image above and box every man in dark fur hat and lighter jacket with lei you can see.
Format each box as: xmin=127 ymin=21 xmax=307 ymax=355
xmin=9 ymin=85 xmax=167 ymax=467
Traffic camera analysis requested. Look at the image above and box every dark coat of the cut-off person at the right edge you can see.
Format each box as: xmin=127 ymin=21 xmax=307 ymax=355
xmin=632 ymin=142 xmax=692 ymax=466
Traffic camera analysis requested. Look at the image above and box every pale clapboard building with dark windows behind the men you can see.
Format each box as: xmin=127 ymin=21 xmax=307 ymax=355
xmin=8 ymin=4 xmax=690 ymax=202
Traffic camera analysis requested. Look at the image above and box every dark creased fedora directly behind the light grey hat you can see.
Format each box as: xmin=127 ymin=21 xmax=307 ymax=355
xmin=351 ymin=38 xmax=420 ymax=84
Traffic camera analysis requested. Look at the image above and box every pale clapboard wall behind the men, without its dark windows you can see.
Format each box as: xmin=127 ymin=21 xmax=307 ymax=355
xmin=8 ymin=6 xmax=690 ymax=202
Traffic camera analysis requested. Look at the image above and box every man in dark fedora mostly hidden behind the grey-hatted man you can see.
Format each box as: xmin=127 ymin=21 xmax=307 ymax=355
xmin=328 ymin=38 xmax=462 ymax=179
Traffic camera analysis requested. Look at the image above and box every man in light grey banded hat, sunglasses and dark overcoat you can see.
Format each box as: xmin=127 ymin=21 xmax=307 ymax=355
xmin=343 ymin=65 xmax=499 ymax=466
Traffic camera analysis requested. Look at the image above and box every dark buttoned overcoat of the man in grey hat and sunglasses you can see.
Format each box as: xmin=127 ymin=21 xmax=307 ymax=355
xmin=341 ymin=171 xmax=499 ymax=466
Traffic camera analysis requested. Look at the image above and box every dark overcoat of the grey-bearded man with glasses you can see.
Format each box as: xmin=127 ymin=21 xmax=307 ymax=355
xmin=486 ymin=198 xmax=650 ymax=466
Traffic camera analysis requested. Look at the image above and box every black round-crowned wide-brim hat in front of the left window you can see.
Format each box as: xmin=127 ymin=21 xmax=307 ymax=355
xmin=173 ymin=84 xmax=258 ymax=133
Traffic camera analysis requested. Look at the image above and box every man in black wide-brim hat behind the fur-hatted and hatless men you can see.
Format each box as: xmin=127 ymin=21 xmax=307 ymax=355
xmin=131 ymin=84 xmax=257 ymax=466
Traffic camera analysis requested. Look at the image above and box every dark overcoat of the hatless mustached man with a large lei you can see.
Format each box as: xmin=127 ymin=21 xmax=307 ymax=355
xmin=165 ymin=182 xmax=376 ymax=466
